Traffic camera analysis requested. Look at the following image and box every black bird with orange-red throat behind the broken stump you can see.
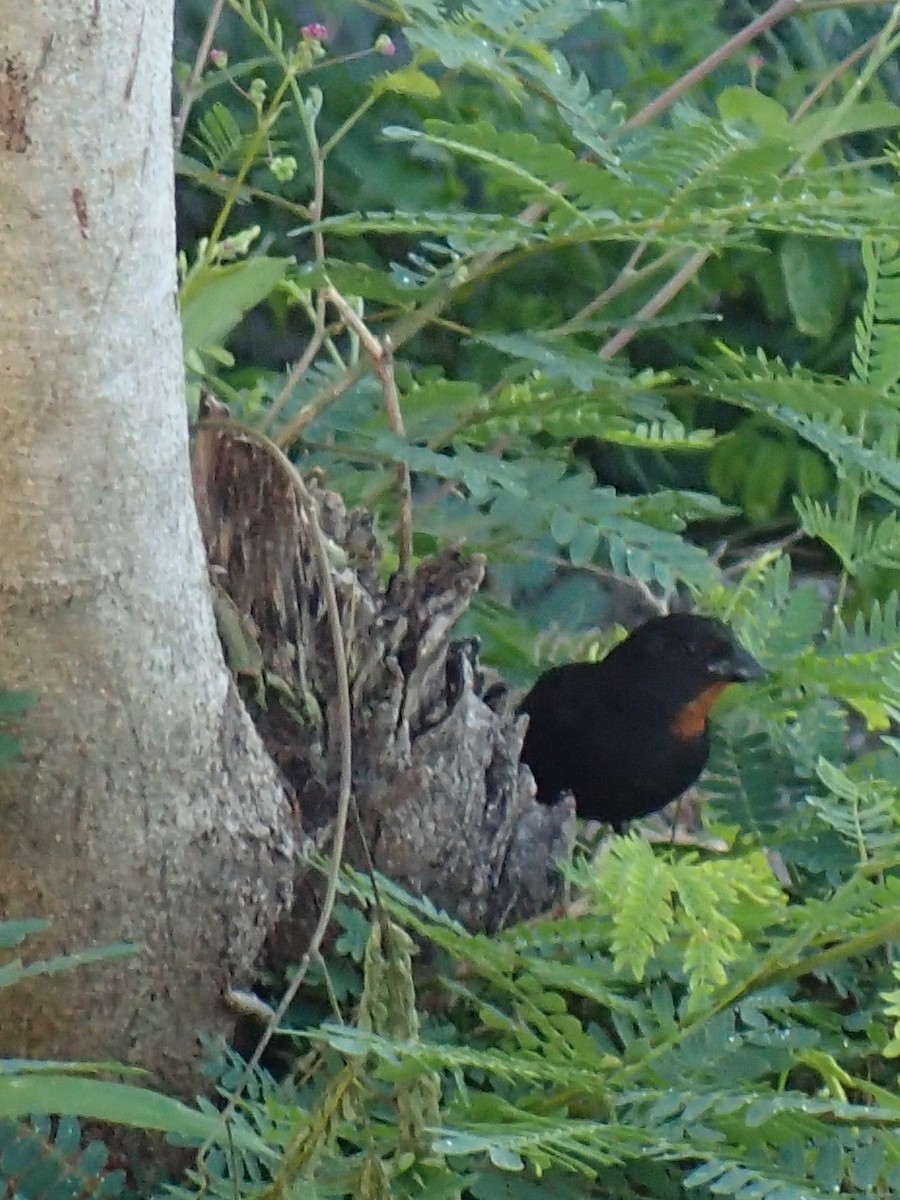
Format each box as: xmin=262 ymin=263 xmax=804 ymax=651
xmin=520 ymin=613 xmax=766 ymax=829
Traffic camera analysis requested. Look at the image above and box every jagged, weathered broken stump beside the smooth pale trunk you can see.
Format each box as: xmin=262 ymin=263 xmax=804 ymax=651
xmin=193 ymin=421 xmax=574 ymax=960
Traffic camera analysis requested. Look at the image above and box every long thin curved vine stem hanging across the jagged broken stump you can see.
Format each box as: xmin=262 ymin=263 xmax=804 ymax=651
xmin=199 ymin=419 xmax=353 ymax=1162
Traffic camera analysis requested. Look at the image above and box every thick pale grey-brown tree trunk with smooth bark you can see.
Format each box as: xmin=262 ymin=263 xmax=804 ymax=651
xmin=0 ymin=0 xmax=293 ymax=1091
